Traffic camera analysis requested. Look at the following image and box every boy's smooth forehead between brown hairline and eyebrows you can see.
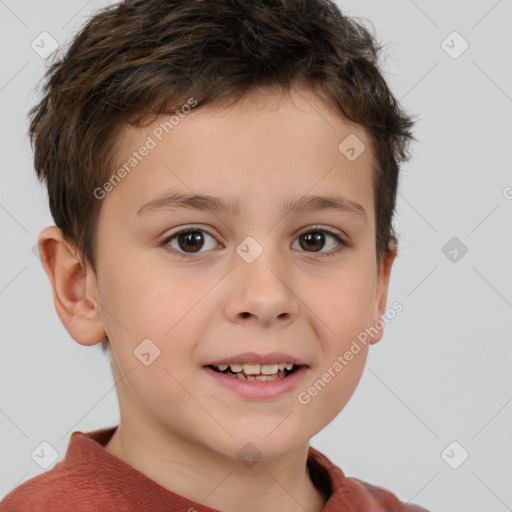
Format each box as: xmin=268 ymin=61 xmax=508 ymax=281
xmin=108 ymin=84 xmax=373 ymax=217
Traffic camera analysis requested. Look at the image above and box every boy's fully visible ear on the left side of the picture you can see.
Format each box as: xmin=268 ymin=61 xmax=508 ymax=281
xmin=38 ymin=226 xmax=106 ymax=345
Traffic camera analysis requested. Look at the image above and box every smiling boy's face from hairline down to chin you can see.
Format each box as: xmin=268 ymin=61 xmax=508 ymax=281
xmin=82 ymin=89 xmax=393 ymax=458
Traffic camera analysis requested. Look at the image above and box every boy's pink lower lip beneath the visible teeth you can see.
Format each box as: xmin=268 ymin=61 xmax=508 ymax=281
xmin=203 ymin=366 xmax=308 ymax=400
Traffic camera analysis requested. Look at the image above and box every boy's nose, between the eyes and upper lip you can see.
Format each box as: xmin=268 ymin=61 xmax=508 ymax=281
xmin=225 ymin=251 xmax=299 ymax=326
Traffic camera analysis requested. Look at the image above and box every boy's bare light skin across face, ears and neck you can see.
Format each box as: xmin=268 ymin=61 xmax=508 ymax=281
xmin=39 ymin=88 xmax=396 ymax=512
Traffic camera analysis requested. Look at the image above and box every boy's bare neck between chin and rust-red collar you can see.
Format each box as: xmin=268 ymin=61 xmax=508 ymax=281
xmin=105 ymin=420 xmax=326 ymax=512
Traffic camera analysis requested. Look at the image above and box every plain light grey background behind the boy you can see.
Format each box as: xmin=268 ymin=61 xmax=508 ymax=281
xmin=0 ymin=0 xmax=512 ymax=512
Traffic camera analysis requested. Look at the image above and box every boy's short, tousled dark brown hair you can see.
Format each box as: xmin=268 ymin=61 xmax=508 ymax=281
xmin=29 ymin=0 xmax=414 ymax=298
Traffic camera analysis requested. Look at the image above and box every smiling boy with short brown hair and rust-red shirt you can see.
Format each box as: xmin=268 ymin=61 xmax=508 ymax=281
xmin=0 ymin=0 xmax=425 ymax=512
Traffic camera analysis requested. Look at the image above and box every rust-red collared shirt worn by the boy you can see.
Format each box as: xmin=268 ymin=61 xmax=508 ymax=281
xmin=0 ymin=427 xmax=428 ymax=512
